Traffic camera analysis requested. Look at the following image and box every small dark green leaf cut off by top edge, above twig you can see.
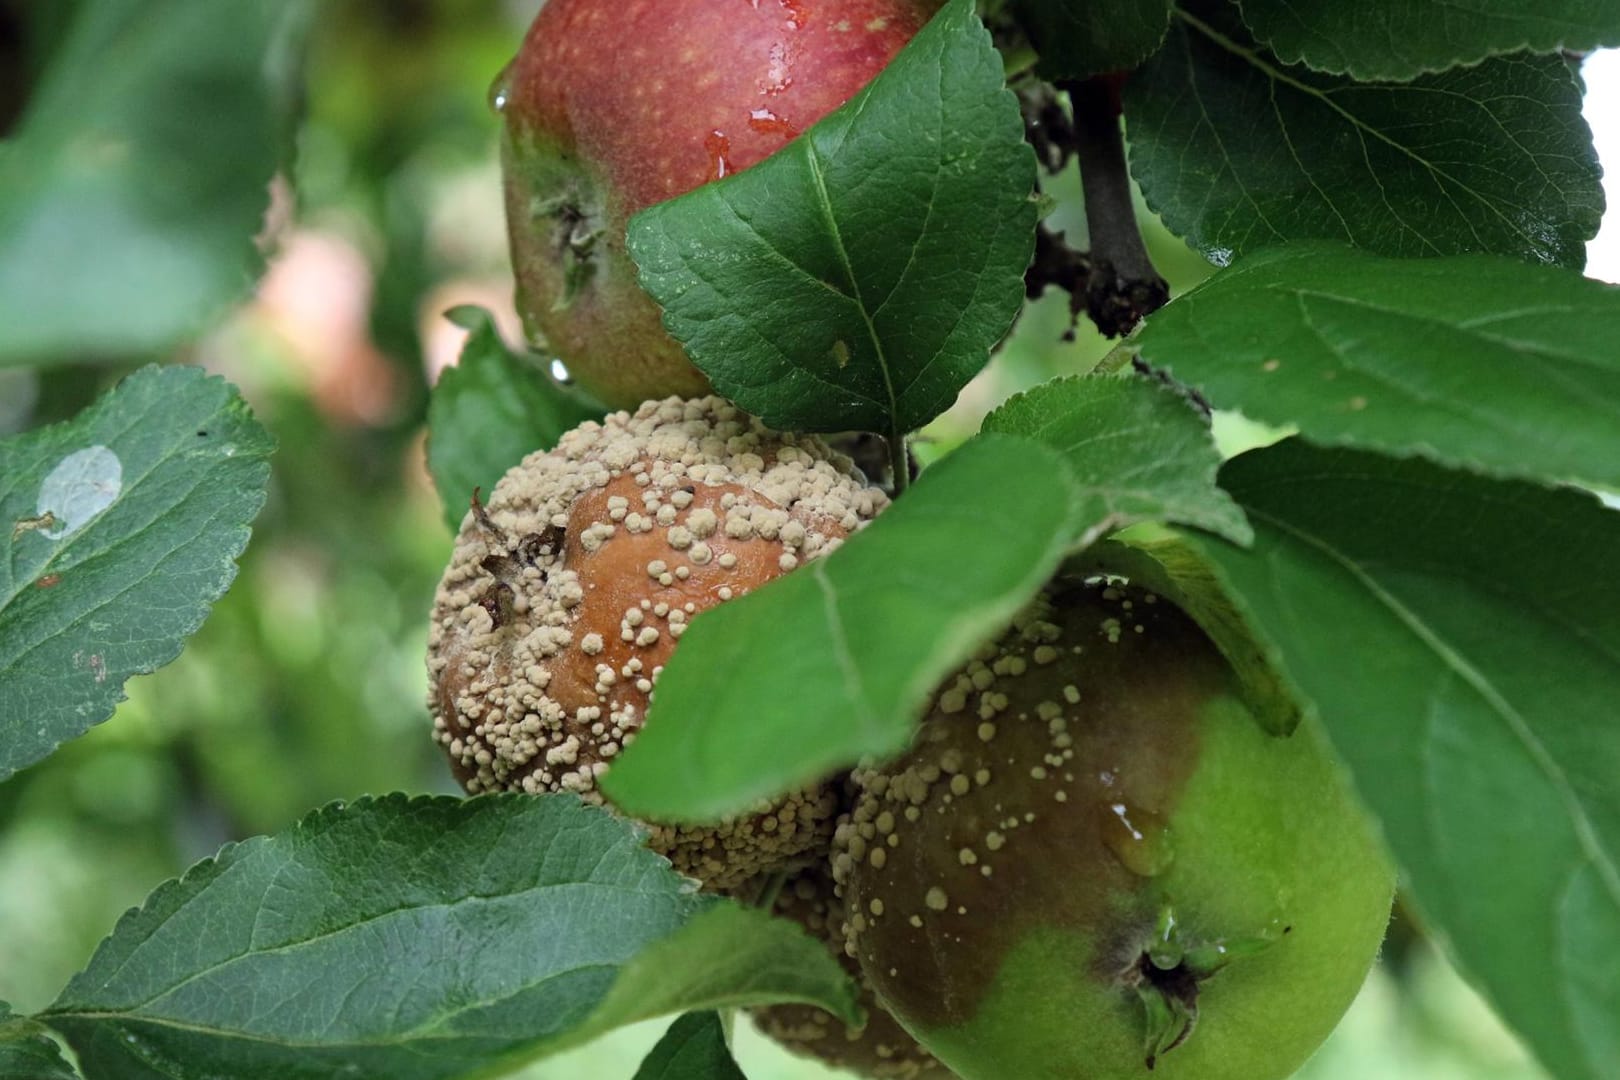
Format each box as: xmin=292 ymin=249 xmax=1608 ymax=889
xmin=1016 ymin=0 xmax=1171 ymax=79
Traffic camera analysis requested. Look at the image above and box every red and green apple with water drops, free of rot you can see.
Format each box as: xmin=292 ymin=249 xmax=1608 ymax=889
xmin=496 ymin=0 xmax=938 ymax=408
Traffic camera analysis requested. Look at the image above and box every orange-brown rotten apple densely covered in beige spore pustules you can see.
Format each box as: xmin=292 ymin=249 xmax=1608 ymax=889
xmin=428 ymin=397 xmax=886 ymax=889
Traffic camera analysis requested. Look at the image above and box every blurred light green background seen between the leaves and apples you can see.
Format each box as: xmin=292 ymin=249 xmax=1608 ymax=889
xmin=0 ymin=0 xmax=1541 ymax=1080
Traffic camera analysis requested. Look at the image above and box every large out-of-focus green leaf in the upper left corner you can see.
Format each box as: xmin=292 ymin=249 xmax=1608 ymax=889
xmin=0 ymin=0 xmax=308 ymax=366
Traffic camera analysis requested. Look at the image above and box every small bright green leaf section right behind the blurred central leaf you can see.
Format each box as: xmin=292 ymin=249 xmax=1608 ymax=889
xmin=985 ymin=376 xmax=1252 ymax=544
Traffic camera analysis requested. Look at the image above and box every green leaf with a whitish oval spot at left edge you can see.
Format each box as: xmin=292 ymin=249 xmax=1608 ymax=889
xmin=0 ymin=368 xmax=274 ymax=779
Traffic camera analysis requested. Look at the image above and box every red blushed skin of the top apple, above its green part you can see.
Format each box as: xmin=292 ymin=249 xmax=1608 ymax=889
xmin=507 ymin=0 xmax=927 ymax=214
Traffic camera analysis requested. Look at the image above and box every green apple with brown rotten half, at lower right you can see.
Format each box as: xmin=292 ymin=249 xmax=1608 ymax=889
xmin=834 ymin=585 xmax=1393 ymax=1080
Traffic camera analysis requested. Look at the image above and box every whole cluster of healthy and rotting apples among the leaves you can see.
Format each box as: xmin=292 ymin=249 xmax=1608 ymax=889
xmin=429 ymin=0 xmax=1393 ymax=1080
